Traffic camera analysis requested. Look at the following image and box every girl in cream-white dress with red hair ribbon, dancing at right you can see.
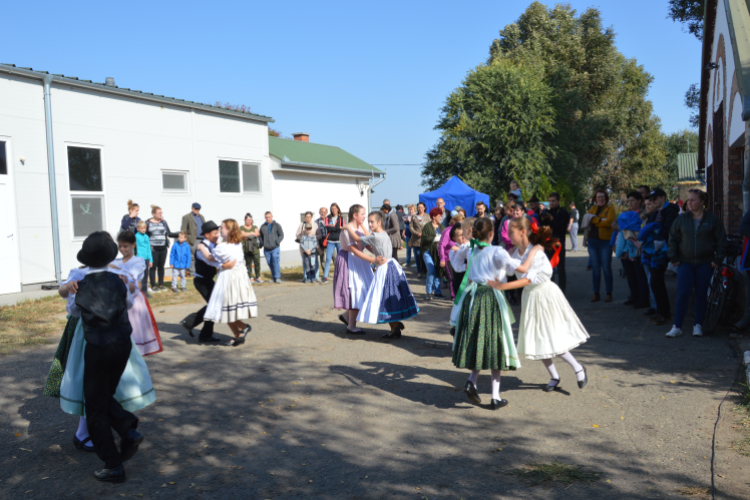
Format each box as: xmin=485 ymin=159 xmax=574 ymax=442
xmin=491 ymin=217 xmax=589 ymax=392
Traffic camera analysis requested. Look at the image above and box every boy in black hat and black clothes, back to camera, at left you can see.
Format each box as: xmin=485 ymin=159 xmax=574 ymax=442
xmin=75 ymin=231 xmax=143 ymax=483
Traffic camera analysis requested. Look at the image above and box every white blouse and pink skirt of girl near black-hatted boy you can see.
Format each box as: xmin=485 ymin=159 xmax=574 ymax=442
xmin=110 ymin=255 xmax=164 ymax=356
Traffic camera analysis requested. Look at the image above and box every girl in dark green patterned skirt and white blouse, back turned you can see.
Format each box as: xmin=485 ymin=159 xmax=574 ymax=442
xmin=453 ymin=218 xmax=530 ymax=410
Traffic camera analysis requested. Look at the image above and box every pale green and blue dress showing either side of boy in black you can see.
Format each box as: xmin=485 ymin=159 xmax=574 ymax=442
xmin=60 ymin=268 xmax=156 ymax=416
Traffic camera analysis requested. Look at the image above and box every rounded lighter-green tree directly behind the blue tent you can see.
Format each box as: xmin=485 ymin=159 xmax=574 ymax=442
xmin=422 ymin=60 xmax=555 ymax=198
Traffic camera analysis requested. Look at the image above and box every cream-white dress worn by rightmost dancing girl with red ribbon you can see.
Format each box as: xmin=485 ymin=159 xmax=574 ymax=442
xmin=513 ymin=245 xmax=589 ymax=359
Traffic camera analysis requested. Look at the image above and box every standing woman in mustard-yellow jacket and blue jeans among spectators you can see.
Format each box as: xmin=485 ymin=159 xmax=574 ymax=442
xmin=588 ymin=189 xmax=617 ymax=302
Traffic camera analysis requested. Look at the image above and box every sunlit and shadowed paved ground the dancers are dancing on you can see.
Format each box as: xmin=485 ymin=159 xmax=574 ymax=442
xmin=0 ymin=252 xmax=750 ymax=500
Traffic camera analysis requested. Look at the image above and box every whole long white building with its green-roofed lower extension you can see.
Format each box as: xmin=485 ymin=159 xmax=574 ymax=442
xmin=0 ymin=64 xmax=383 ymax=294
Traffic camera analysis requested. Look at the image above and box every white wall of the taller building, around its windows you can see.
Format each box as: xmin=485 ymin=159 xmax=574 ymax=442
xmin=0 ymin=72 xmax=272 ymax=285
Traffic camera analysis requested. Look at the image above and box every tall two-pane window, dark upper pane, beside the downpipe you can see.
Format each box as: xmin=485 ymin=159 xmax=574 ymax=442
xmin=68 ymin=146 xmax=104 ymax=238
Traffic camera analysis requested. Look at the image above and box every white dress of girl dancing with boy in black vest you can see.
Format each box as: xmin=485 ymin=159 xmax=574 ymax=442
xmin=204 ymin=243 xmax=258 ymax=323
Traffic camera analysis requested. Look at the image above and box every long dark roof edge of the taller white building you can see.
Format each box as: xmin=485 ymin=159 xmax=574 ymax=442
xmin=0 ymin=64 xmax=274 ymax=123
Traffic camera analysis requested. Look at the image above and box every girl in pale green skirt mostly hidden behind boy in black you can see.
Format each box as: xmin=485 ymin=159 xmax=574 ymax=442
xmin=56 ymin=233 xmax=156 ymax=452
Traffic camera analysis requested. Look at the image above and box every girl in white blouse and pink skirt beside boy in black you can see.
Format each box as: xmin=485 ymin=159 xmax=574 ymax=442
xmin=109 ymin=231 xmax=164 ymax=356
